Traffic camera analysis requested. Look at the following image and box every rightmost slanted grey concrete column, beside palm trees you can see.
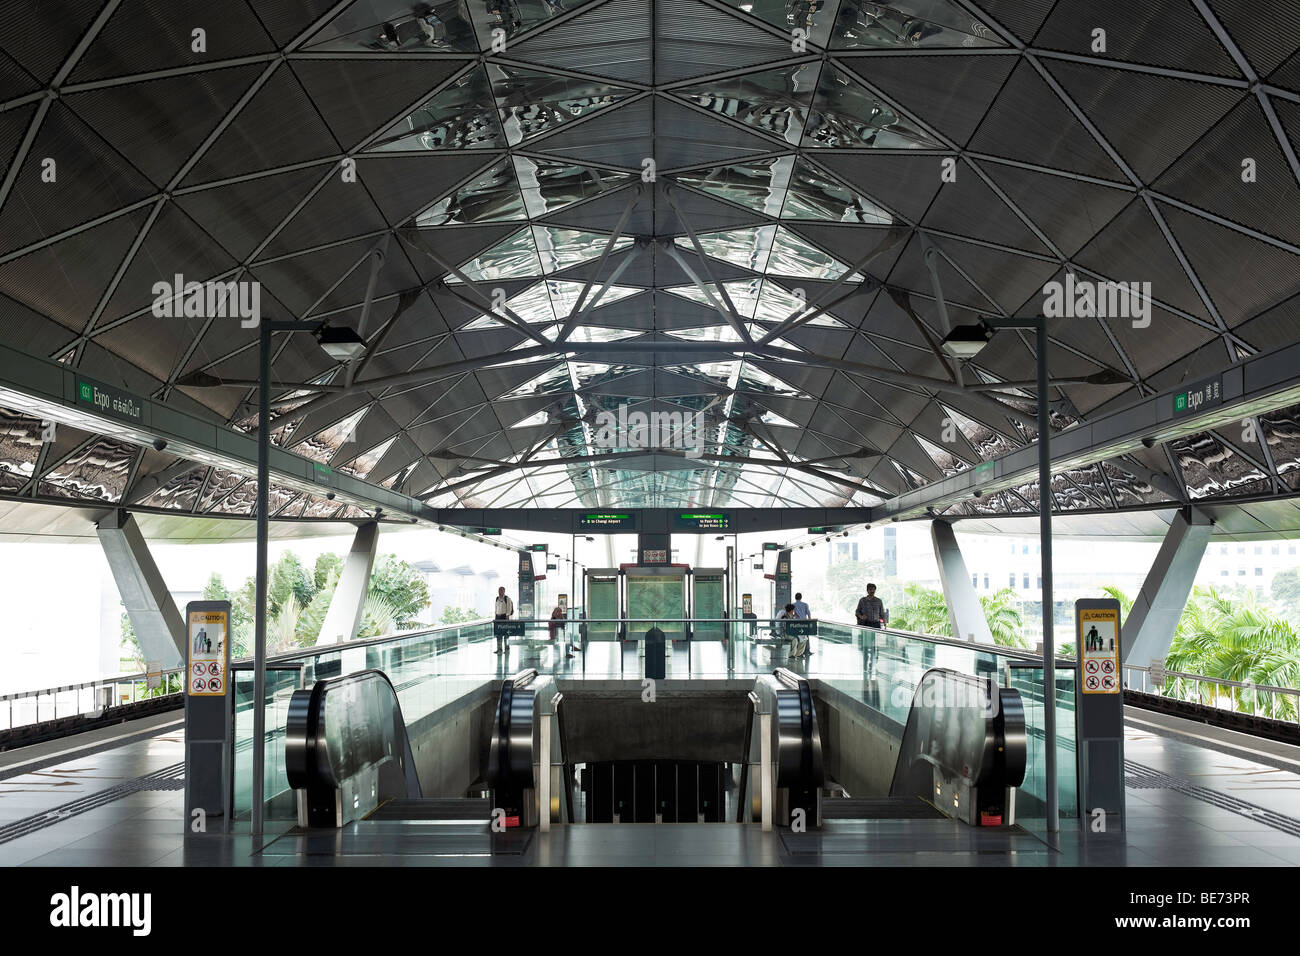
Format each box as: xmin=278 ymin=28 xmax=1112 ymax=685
xmin=1121 ymin=507 xmax=1213 ymax=667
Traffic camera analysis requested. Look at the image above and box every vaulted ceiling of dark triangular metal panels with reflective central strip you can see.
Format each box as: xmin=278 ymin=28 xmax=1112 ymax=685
xmin=0 ymin=0 xmax=1300 ymax=518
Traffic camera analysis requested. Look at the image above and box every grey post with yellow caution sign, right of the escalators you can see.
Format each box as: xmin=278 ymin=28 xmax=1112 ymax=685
xmin=1074 ymin=598 xmax=1125 ymax=835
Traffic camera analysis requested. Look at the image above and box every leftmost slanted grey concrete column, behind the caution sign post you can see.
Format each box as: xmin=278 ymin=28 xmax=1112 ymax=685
xmin=95 ymin=510 xmax=186 ymax=667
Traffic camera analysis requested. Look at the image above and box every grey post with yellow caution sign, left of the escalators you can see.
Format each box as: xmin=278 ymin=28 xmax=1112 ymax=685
xmin=185 ymin=601 xmax=233 ymax=834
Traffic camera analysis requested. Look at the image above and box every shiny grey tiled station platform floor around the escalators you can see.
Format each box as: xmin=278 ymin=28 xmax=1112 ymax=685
xmin=0 ymin=686 xmax=1300 ymax=868
